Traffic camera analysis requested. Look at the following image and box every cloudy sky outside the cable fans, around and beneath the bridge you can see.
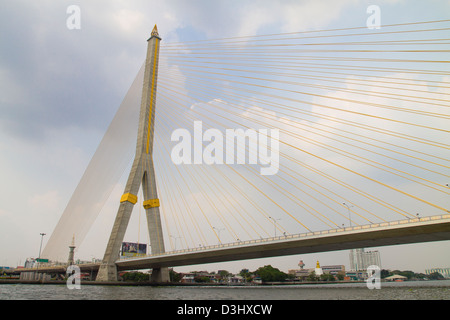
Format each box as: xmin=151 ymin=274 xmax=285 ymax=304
xmin=0 ymin=0 xmax=450 ymax=272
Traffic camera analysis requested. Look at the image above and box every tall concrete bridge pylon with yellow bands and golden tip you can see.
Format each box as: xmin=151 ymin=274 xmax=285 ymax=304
xmin=96 ymin=25 xmax=169 ymax=282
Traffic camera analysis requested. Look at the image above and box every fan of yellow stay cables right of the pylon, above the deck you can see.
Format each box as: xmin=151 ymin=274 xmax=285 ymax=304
xmin=149 ymin=20 xmax=450 ymax=250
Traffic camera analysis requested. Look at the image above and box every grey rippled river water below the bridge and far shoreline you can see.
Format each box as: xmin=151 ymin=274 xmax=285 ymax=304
xmin=0 ymin=280 xmax=450 ymax=301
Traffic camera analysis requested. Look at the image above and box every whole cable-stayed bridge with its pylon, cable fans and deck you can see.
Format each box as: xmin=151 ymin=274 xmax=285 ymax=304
xmin=24 ymin=20 xmax=450 ymax=280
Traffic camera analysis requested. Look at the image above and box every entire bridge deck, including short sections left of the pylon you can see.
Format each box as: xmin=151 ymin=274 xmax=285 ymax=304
xmin=16 ymin=214 xmax=450 ymax=273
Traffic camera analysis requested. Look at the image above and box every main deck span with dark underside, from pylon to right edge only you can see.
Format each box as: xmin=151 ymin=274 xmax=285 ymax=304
xmin=116 ymin=215 xmax=450 ymax=270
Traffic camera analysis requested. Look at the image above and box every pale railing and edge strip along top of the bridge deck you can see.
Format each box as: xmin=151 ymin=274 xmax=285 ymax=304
xmin=120 ymin=214 xmax=450 ymax=260
